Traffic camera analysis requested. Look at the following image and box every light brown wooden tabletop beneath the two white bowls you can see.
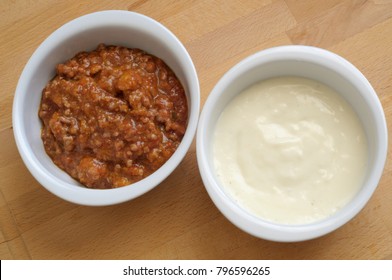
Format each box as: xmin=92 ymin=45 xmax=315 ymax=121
xmin=0 ymin=0 xmax=392 ymax=259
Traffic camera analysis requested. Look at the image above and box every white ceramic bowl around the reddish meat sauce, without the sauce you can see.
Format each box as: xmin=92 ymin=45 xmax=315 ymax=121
xmin=13 ymin=11 xmax=200 ymax=206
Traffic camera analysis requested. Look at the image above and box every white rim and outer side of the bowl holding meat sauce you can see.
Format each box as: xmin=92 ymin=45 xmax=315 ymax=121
xmin=12 ymin=10 xmax=200 ymax=206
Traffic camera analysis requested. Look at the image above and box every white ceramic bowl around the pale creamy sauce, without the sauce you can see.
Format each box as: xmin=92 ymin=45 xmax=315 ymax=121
xmin=196 ymin=46 xmax=388 ymax=242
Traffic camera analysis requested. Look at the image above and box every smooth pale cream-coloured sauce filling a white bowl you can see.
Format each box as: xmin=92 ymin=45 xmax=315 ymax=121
xmin=213 ymin=77 xmax=367 ymax=224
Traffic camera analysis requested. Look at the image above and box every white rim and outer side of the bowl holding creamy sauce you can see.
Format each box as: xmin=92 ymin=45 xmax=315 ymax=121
xmin=196 ymin=45 xmax=388 ymax=242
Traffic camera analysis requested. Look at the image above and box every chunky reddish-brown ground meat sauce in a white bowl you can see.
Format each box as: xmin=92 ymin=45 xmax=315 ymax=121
xmin=39 ymin=45 xmax=188 ymax=189
